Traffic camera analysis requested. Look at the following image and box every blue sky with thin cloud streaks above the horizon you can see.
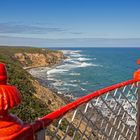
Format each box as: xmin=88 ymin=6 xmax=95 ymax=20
xmin=0 ymin=0 xmax=140 ymax=47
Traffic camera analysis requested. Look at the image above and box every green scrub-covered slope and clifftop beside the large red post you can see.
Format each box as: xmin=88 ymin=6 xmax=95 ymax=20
xmin=0 ymin=47 xmax=58 ymax=121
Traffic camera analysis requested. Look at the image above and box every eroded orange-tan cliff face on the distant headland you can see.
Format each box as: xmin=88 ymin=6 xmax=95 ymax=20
xmin=14 ymin=51 xmax=65 ymax=68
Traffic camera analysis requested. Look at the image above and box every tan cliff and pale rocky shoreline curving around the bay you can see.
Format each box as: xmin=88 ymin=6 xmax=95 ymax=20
xmin=15 ymin=47 xmax=74 ymax=103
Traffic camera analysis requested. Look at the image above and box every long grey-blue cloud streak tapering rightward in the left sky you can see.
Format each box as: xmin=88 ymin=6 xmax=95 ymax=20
xmin=0 ymin=22 xmax=65 ymax=34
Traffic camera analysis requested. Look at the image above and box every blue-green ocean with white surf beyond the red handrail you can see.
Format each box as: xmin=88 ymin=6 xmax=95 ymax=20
xmin=29 ymin=48 xmax=140 ymax=97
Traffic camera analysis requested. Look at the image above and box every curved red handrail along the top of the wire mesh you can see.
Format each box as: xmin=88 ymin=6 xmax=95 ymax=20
xmin=11 ymin=79 xmax=140 ymax=139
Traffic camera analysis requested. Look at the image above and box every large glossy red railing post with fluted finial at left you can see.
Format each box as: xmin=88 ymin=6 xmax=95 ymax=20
xmin=0 ymin=63 xmax=24 ymax=140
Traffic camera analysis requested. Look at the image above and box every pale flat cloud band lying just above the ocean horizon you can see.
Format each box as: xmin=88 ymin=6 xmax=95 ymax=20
xmin=0 ymin=36 xmax=140 ymax=47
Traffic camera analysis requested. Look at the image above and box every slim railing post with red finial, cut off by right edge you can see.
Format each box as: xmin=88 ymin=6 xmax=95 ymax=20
xmin=134 ymin=59 xmax=140 ymax=140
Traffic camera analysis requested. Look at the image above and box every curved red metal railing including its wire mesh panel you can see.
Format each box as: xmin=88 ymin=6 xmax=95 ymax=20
xmin=0 ymin=61 xmax=140 ymax=140
